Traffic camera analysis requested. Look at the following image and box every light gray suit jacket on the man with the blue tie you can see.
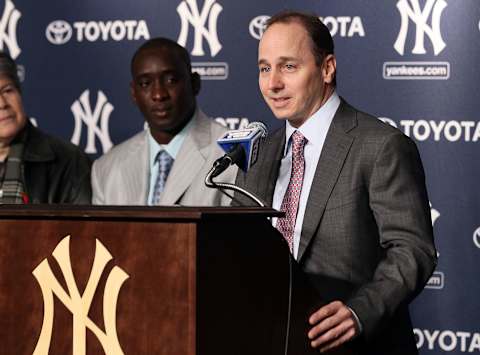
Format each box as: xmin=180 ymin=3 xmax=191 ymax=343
xmin=92 ymin=111 xmax=237 ymax=206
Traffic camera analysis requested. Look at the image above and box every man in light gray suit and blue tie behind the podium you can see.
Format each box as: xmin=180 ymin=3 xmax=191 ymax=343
xmin=92 ymin=38 xmax=236 ymax=206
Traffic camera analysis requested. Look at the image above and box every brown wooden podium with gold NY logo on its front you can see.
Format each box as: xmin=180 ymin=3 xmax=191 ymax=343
xmin=0 ymin=205 xmax=352 ymax=355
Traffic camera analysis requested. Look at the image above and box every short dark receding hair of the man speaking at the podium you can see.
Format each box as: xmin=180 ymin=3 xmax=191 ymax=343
xmin=266 ymin=10 xmax=334 ymax=79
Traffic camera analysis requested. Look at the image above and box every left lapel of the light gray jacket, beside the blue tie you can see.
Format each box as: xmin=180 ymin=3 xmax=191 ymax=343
xmin=122 ymin=131 xmax=150 ymax=205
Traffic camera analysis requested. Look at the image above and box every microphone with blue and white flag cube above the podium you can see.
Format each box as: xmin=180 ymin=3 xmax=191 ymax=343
xmin=211 ymin=122 xmax=267 ymax=178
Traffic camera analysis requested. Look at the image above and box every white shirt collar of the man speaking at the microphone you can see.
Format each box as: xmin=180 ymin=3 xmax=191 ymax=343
xmin=283 ymin=91 xmax=340 ymax=156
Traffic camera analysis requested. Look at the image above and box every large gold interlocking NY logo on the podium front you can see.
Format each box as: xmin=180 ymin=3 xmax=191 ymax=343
xmin=32 ymin=236 xmax=129 ymax=355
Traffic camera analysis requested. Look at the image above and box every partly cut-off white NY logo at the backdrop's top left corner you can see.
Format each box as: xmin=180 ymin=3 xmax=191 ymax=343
xmin=0 ymin=0 xmax=22 ymax=59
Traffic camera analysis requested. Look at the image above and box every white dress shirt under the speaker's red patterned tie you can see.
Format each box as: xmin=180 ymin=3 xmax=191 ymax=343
xmin=272 ymin=92 xmax=340 ymax=259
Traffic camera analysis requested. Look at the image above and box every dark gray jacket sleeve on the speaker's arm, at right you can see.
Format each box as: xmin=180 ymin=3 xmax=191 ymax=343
xmin=347 ymin=134 xmax=436 ymax=338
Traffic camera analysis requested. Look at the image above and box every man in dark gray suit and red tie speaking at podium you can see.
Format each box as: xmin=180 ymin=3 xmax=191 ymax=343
xmin=236 ymin=12 xmax=436 ymax=355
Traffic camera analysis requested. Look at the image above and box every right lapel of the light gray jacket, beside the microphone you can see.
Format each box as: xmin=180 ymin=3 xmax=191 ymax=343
xmin=160 ymin=111 xmax=211 ymax=205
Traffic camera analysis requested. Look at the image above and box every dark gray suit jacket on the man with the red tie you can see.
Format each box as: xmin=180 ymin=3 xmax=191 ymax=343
xmin=235 ymin=100 xmax=436 ymax=355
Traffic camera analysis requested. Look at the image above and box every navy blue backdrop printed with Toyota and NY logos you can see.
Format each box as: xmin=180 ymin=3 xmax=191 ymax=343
xmin=4 ymin=0 xmax=480 ymax=354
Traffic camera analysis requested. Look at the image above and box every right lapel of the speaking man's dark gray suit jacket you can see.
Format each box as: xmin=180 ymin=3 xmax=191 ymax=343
xmin=297 ymin=100 xmax=356 ymax=262
